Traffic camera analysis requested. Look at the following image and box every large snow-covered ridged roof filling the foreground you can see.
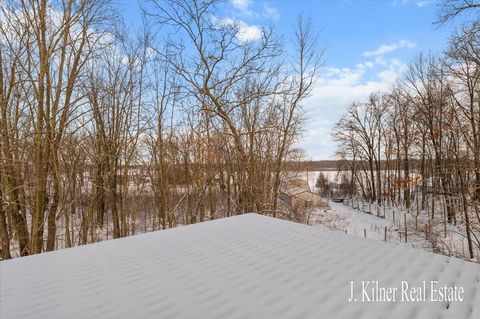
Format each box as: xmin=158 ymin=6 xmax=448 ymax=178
xmin=0 ymin=214 xmax=480 ymax=319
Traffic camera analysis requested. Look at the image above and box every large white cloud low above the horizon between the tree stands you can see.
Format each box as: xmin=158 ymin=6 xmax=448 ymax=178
xmin=297 ymin=58 xmax=406 ymax=159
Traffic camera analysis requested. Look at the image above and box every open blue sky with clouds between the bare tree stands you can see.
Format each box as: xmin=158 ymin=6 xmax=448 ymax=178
xmin=119 ymin=0 xmax=453 ymax=160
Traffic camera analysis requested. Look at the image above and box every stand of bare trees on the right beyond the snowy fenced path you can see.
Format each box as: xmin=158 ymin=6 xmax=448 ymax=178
xmin=333 ymin=5 xmax=480 ymax=258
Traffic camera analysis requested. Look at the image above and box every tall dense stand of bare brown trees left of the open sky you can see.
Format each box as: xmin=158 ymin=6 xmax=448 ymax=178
xmin=0 ymin=0 xmax=322 ymax=259
